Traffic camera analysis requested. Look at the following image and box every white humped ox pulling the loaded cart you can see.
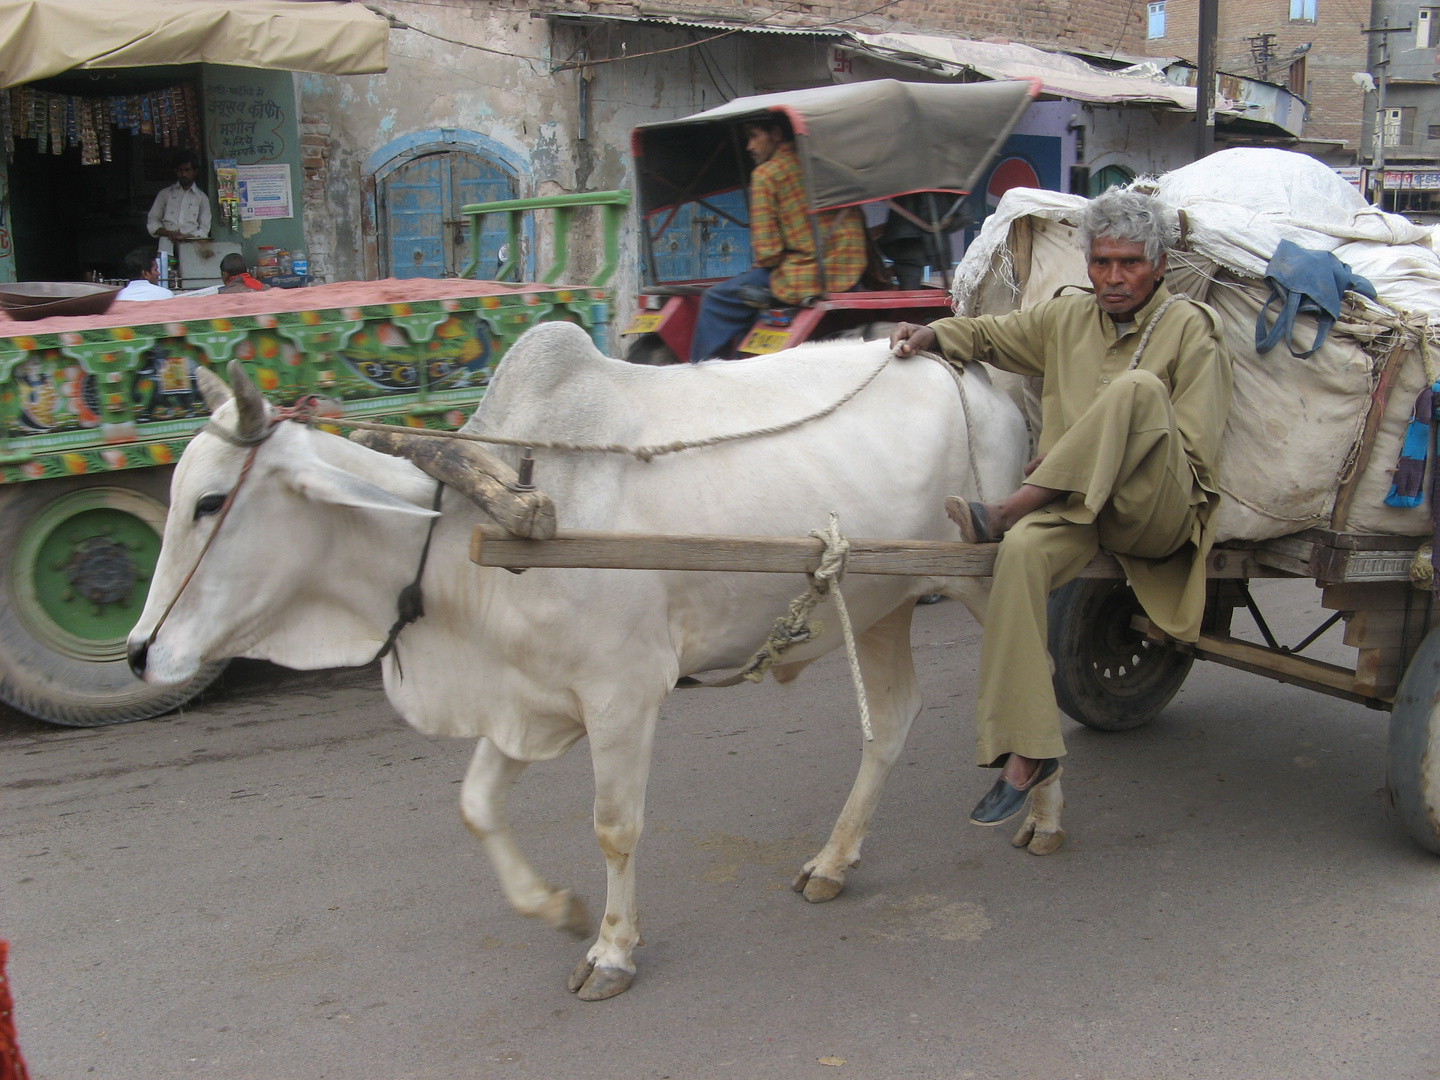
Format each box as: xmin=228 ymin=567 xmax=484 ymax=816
xmin=131 ymin=323 xmax=1025 ymax=999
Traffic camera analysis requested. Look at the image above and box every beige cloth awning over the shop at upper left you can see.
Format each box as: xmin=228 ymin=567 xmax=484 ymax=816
xmin=0 ymin=0 xmax=389 ymax=86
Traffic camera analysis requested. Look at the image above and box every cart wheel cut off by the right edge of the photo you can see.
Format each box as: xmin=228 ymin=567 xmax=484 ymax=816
xmin=1385 ymin=631 xmax=1440 ymax=855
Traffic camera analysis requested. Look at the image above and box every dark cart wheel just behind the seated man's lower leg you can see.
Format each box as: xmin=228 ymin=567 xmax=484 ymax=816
xmin=1045 ymin=577 xmax=1194 ymax=732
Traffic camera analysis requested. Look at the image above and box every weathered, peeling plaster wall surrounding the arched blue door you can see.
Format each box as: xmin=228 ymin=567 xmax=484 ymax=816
xmin=297 ymin=0 xmax=829 ymax=311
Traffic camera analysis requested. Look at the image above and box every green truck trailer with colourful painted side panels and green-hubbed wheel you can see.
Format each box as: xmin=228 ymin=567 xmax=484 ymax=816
xmin=0 ymin=192 xmax=629 ymax=727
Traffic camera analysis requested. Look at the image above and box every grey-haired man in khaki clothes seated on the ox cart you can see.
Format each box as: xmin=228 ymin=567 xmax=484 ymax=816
xmin=891 ymin=190 xmax=1231 ymax=825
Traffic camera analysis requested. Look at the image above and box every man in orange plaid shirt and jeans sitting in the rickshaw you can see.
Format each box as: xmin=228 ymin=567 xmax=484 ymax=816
xmin=690 ymin=118 xmax=865 ymax=363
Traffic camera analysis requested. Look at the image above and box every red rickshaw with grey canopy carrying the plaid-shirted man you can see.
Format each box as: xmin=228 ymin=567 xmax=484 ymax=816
xmin=622 ymin=79 xmax=1040 ymax=363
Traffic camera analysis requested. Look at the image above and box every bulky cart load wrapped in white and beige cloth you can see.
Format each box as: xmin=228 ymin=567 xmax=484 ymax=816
xmin=955 ymin=150 xmax=1440 ymax=540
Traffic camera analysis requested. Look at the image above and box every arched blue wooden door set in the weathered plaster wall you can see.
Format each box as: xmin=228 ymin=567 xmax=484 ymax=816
xmin=380 ymin=150 xmax=514 ymax=278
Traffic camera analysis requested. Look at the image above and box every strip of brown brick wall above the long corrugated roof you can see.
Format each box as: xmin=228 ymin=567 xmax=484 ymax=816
xmin=529 ymin=0 xmax=1145 ymax=53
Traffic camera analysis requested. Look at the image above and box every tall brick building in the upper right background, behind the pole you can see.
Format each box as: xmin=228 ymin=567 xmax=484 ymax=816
xmin=1136 ymin=0 xmax=1369 ymax=148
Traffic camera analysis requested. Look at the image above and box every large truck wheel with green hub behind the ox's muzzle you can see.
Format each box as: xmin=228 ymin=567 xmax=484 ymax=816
xmin=0 ymin=469 xmax=225 ymax=727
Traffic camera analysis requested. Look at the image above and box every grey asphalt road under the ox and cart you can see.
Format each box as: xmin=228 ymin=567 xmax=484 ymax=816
xmin=0 ymin=583 xmax=1440 ymax=1080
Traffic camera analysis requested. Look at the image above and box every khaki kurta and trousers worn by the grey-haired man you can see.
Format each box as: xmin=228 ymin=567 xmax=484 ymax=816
xmin=930 ymin=284 xmax=1231 ymax=765
